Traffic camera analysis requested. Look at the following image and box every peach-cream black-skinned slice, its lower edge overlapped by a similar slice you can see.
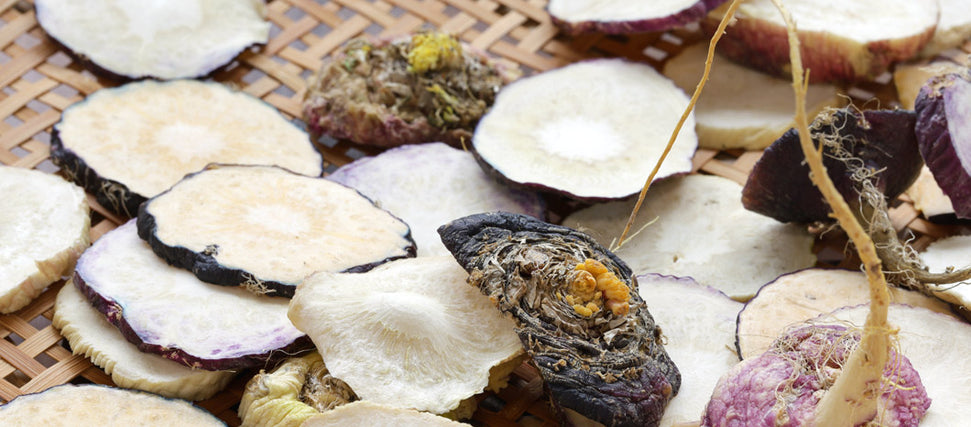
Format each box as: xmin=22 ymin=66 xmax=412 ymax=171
xmin=51 ymin=80 xmax=323 ymax=217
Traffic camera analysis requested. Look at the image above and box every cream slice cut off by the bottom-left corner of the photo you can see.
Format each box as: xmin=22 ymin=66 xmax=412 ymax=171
xmin=0 ymin=384 xmax=226 ymax=427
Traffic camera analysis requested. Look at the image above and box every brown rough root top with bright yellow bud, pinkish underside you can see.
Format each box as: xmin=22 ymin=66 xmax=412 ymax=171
xmin=303 ymin=32 xmax=516 ymax=147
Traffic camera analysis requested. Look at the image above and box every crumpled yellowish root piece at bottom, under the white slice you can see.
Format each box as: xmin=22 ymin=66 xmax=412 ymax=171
xmin=239 ymin=352 xmax=357 ymax=427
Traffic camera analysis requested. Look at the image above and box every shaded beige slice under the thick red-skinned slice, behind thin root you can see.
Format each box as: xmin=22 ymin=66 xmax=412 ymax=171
xmin=664 ymin=43 xmax=844 ymax=150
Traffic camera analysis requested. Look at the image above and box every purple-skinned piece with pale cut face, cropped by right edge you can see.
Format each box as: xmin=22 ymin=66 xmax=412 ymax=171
xmin=915 ymin=71 xmax=971 ymax=219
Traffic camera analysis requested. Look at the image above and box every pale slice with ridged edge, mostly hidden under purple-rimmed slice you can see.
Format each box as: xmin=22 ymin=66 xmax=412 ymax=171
xmin=52 ymin=282 xmax=236 ymax=400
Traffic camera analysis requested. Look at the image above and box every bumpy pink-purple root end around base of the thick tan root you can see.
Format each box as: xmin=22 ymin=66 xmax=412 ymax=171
xmin=701 ymin=325 xmax=931 ymax=427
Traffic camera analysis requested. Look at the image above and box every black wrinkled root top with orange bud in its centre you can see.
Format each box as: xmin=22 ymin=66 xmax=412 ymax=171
xmin=438 ymin=212 xmax=681 ymax=426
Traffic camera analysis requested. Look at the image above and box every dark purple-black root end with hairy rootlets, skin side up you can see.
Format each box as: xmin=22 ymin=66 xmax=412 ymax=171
xmin=742 ymin=109 xmax=923 ymax=222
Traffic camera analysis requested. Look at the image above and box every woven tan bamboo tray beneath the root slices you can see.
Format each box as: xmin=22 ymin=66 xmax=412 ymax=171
xmin=0 ymin=0 xmax=968 ymax=426
